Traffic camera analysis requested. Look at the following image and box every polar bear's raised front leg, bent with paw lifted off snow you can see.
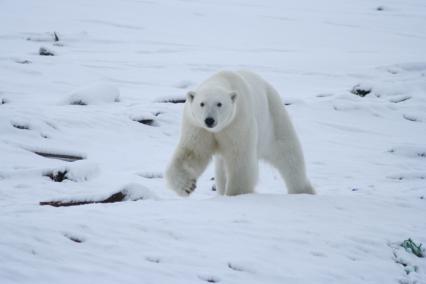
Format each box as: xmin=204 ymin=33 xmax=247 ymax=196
xmin=165 ymin=129 xmax=213 ymax=196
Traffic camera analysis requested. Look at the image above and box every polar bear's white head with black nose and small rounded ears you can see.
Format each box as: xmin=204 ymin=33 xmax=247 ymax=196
xmin=187 ymin=88 xmax=237 ymax=132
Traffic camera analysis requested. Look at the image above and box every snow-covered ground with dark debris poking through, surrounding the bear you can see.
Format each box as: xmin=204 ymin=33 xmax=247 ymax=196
xmin=0 ymin=0 xmax=426 ymax=284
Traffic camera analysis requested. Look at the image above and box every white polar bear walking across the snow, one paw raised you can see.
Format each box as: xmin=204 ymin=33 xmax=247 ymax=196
xmin=165 ymin=71 xmax=315 ymax=196
